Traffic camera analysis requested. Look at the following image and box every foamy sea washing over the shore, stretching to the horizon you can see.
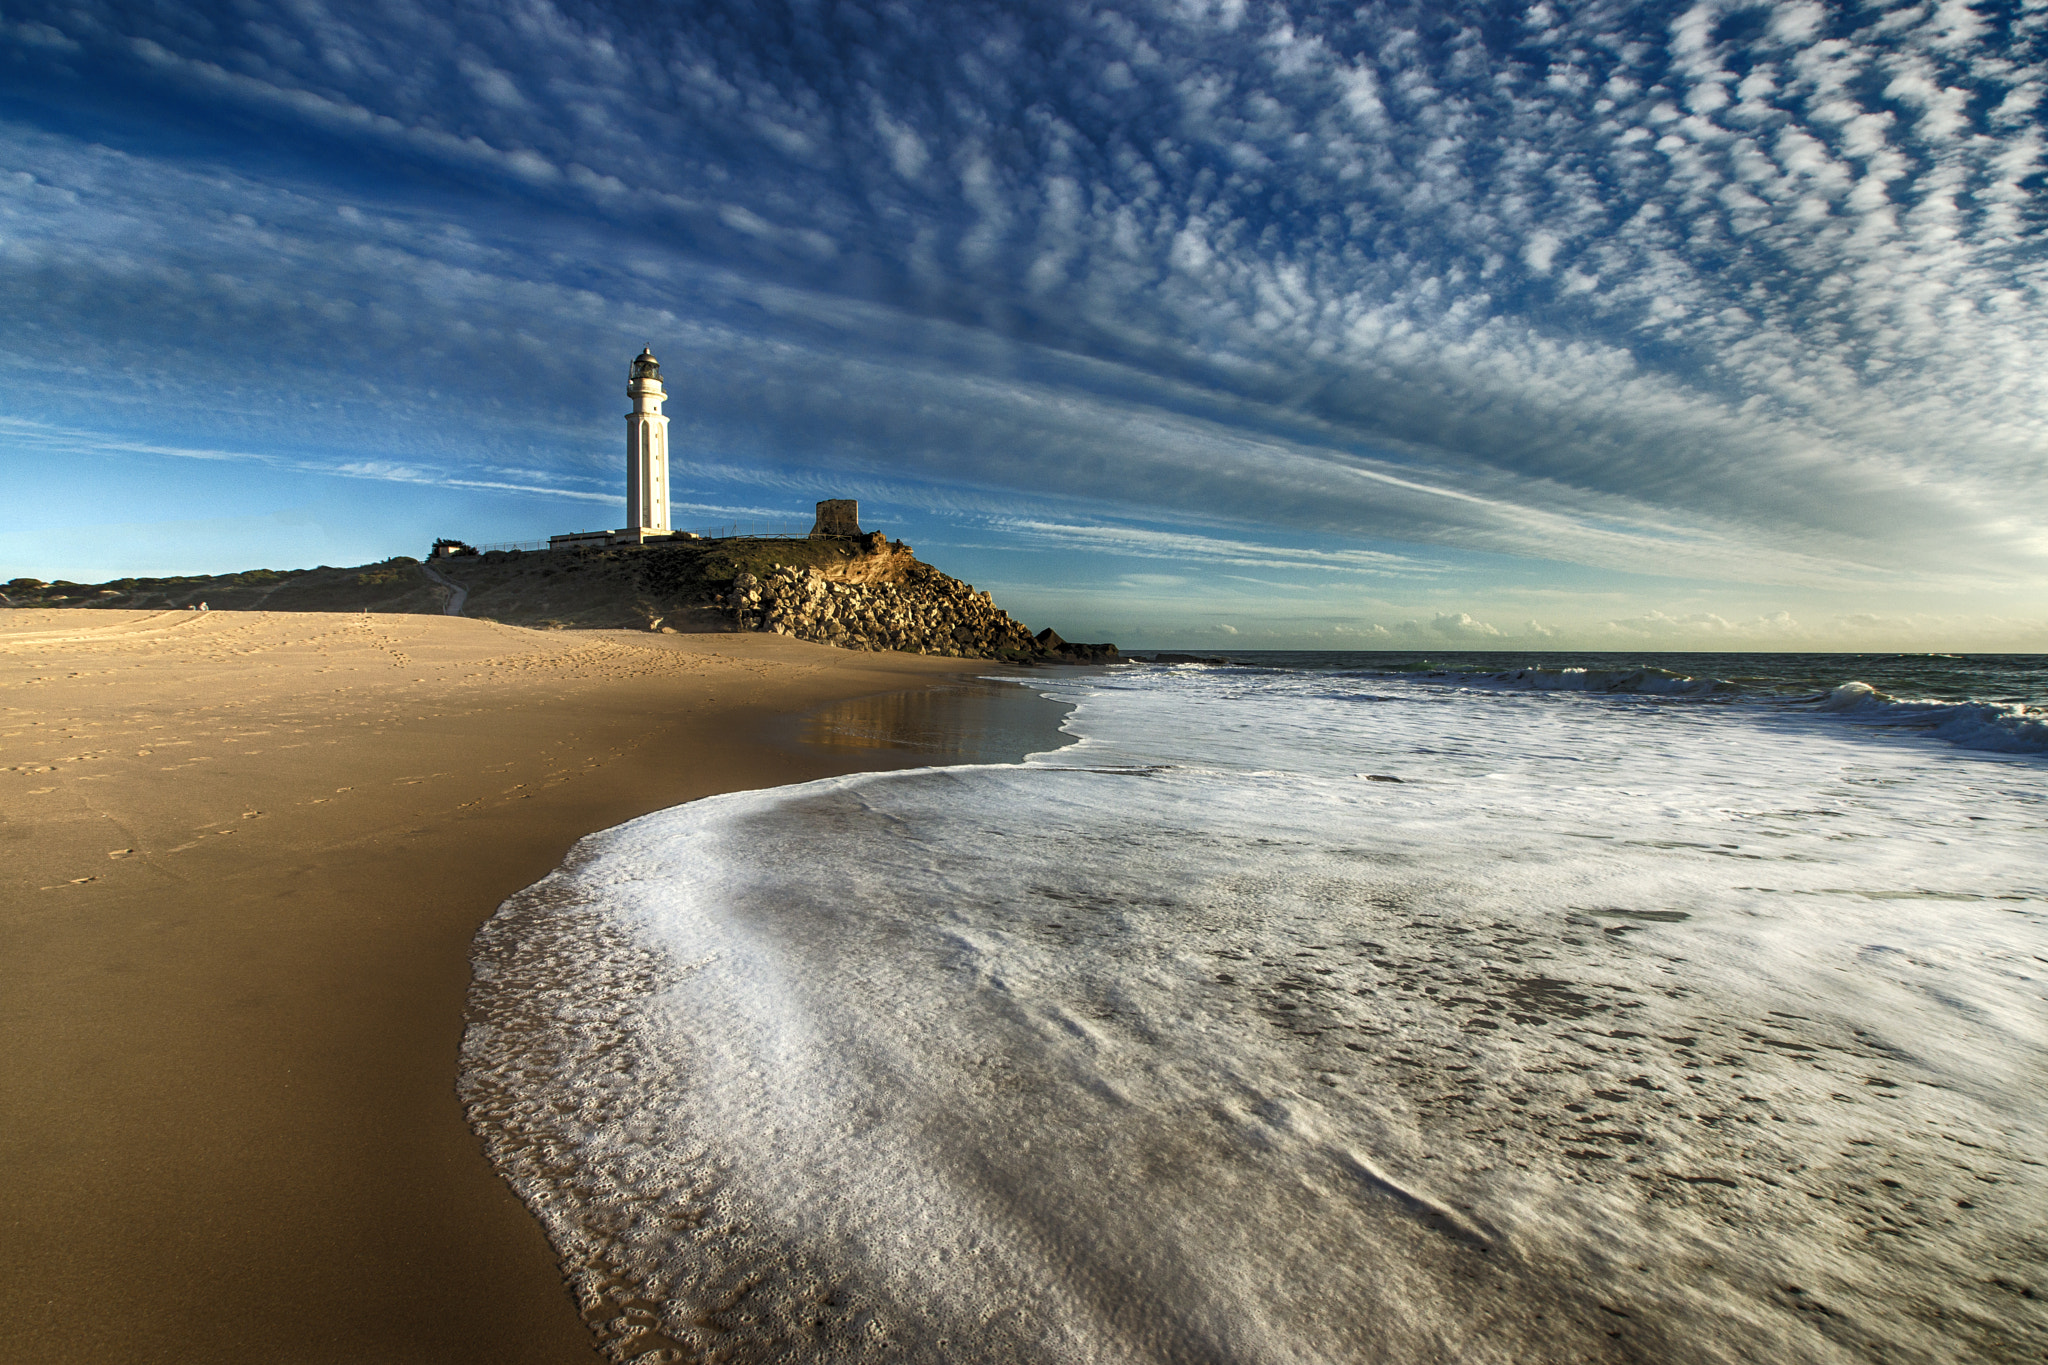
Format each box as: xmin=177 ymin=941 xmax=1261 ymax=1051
xmin=461 ymin=653 xmax=2048 ymax=1365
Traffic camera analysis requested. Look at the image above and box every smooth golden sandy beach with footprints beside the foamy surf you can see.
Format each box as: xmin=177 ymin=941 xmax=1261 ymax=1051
xmin=0 ymin=610 xmax=1024 ymax=1363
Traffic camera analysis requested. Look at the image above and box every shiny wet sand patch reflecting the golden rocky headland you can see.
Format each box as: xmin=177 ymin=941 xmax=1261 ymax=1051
xmin=795 ymin=677 xmax=1071 ymax=767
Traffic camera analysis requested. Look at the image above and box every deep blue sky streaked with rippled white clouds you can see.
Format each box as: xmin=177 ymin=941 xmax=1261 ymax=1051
xmin=0 ymin=0 xmax=2048 ymax=653
